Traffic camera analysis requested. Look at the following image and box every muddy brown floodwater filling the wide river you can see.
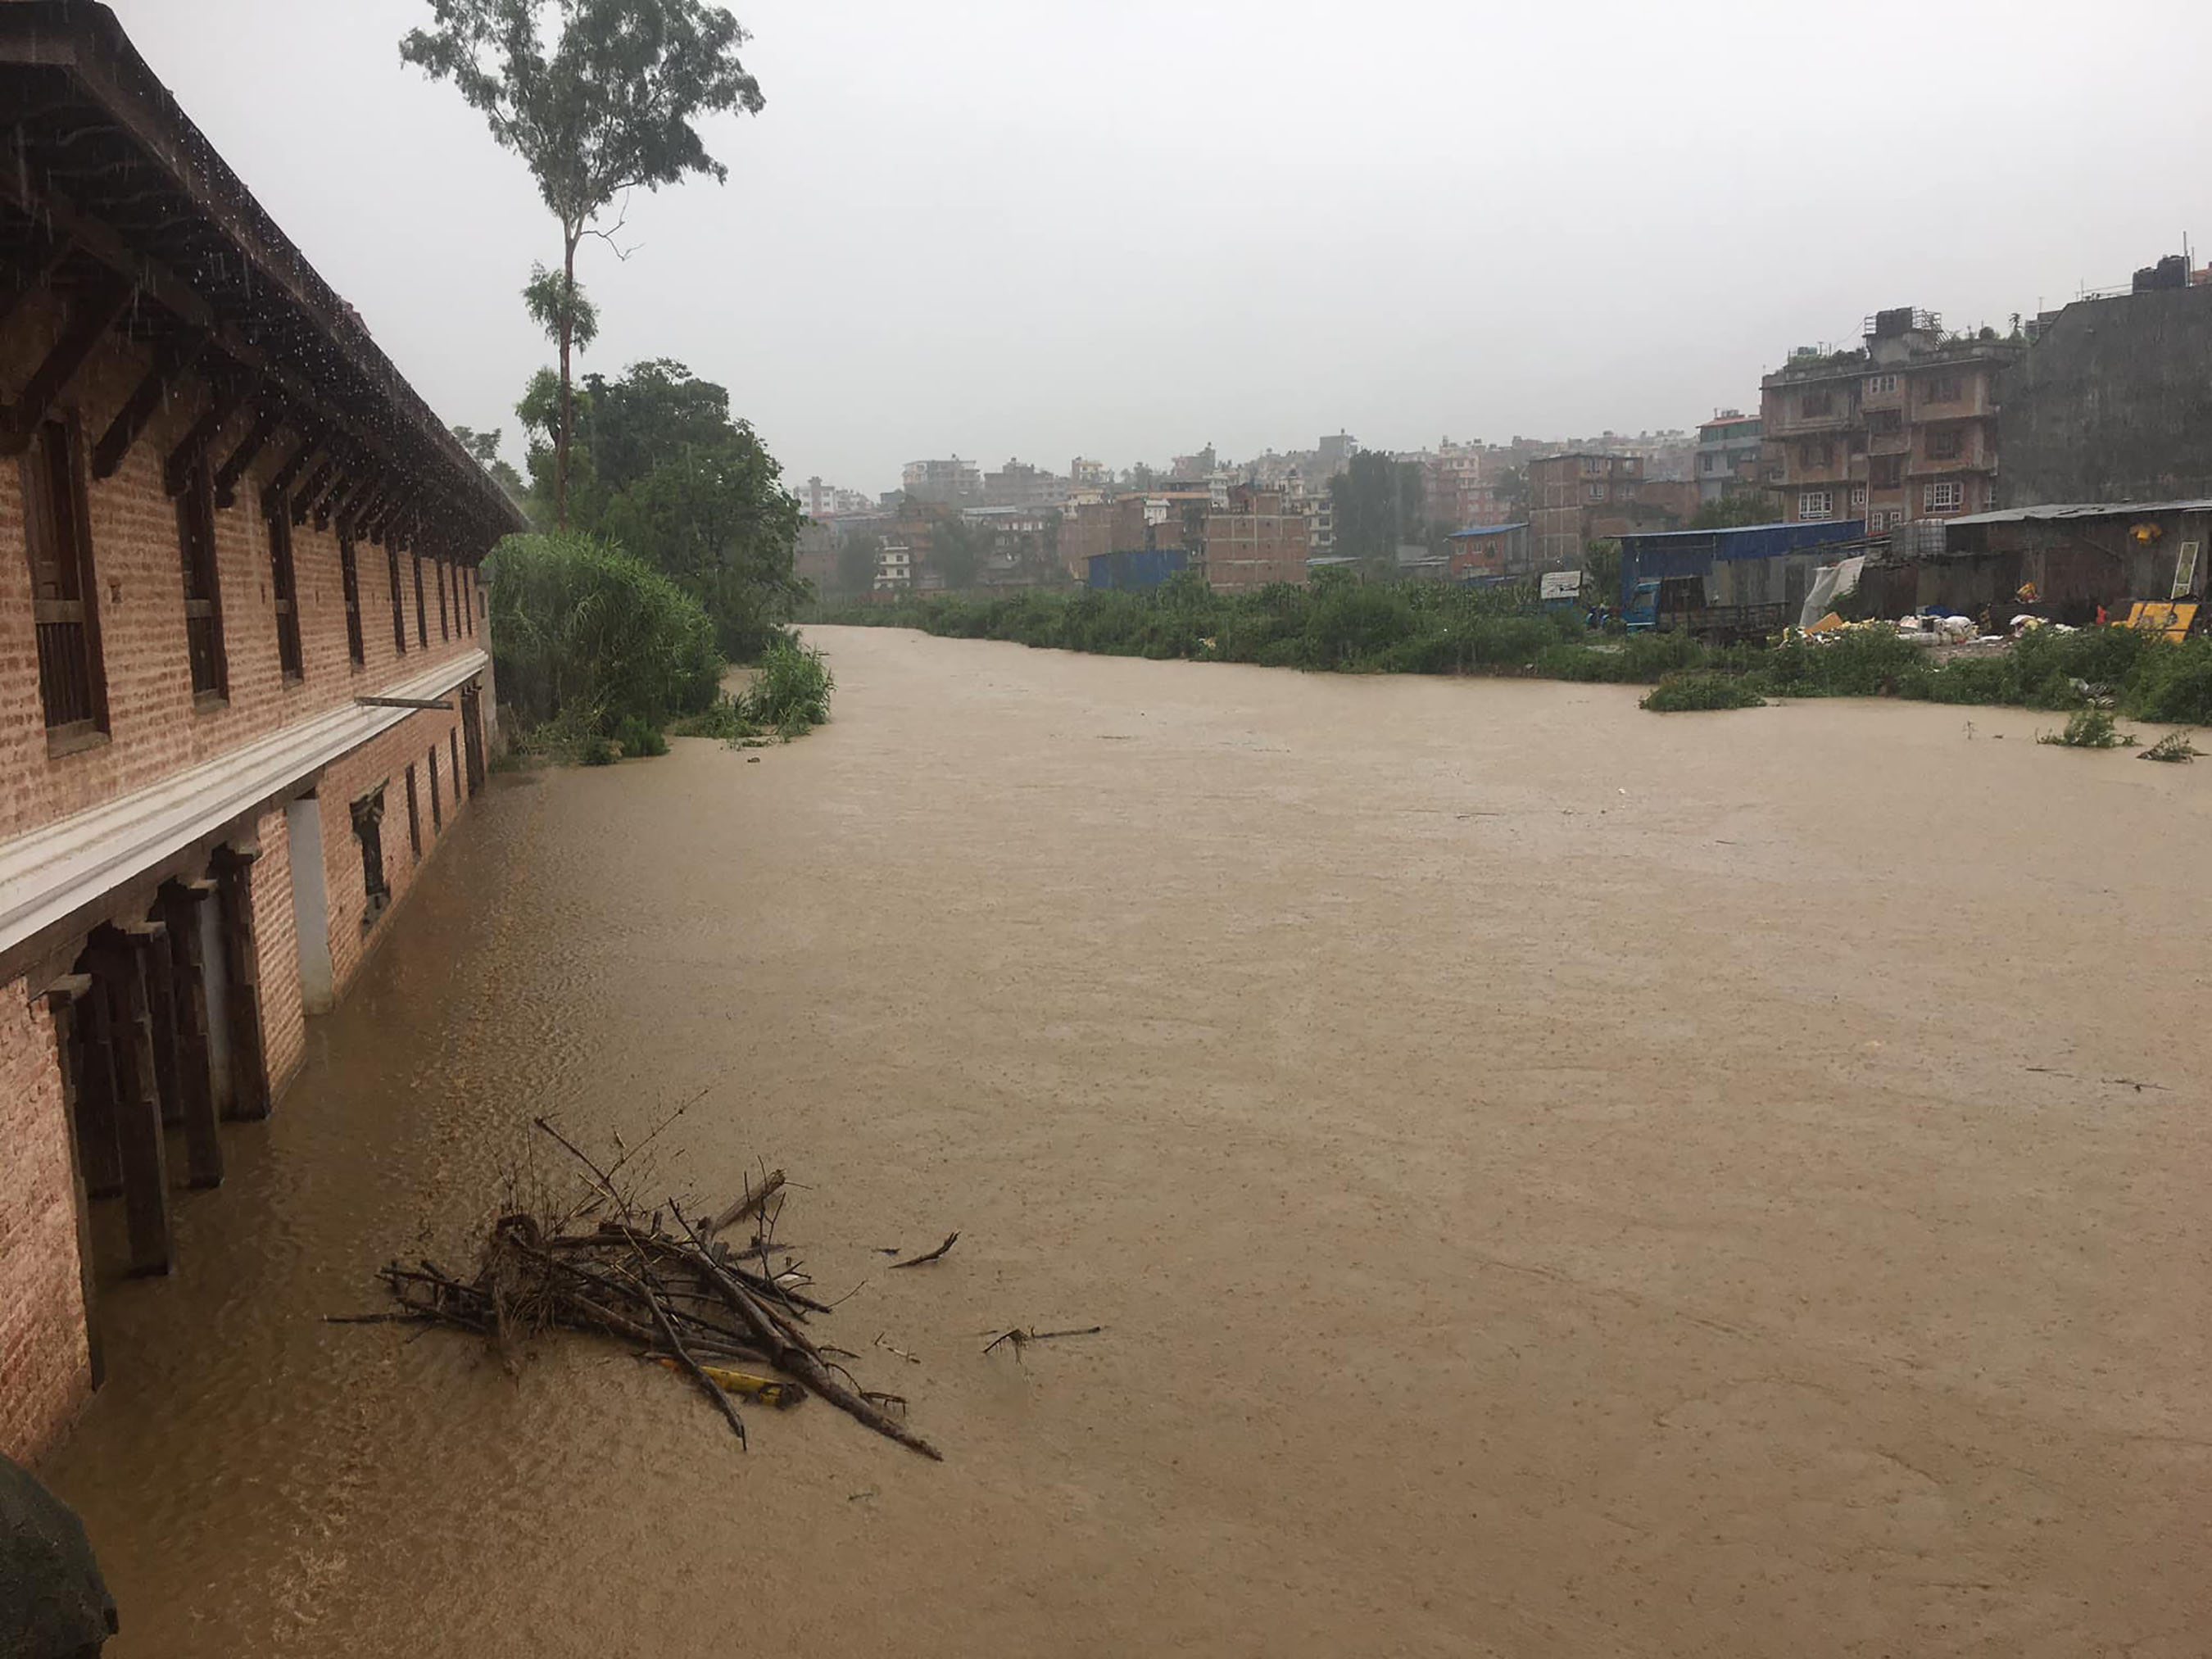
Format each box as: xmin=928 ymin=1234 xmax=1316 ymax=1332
xmin=34 ymin=631 xmax=2212 ymax=1659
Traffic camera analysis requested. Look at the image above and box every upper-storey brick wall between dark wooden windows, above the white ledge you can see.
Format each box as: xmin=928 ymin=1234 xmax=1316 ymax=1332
xmin=0 ymin=296 xmax=491 ymax=841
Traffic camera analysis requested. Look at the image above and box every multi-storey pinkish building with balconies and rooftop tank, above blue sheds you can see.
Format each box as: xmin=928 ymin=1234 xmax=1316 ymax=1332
xmin=1759 ymin=307 xmax=2024 ymax=535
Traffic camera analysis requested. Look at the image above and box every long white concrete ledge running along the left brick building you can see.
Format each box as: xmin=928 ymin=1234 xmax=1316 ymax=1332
xmin=0 ymin=650 xmax=491 ymax=951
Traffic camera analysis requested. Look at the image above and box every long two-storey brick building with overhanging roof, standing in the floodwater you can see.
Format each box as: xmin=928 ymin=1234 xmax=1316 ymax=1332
xmin=0 ymin=0 xmax=522 ymax=1457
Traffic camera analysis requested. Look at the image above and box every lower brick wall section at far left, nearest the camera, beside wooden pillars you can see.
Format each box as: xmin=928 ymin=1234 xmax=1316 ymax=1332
xmin=0 ymin=980 xmax=93 ymax=1462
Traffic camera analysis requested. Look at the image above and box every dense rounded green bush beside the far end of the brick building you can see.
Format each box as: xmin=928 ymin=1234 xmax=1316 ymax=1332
xmin=491 ymin=535 xmax=721 ymax=737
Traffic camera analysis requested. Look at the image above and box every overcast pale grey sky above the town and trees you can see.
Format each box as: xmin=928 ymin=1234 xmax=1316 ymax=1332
xmin=111 ymin=0 xmax=2212 ymax=491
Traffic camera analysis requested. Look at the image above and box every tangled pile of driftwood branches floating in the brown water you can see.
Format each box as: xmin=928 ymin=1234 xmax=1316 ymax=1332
xmin=356 ymin=1119 xmax=951 ymax=1457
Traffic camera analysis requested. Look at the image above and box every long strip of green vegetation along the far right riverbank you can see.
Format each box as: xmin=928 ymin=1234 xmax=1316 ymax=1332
xmin=809 ymin=571 xmax=2212 ymax=726
